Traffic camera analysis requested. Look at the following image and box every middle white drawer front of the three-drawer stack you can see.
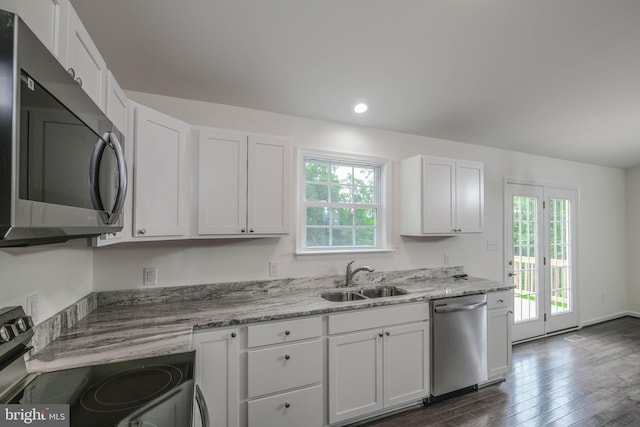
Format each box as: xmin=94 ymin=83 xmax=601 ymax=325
xmin=247 ymin=339 xmax=322 ymax=398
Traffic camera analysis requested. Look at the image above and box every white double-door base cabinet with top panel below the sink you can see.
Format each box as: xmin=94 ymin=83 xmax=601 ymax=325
xmin=328 ymin=303 xmax=429 ymax=424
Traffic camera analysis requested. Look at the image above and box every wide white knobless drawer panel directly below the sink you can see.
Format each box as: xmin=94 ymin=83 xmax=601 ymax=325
xmin=329 ymin=303 xmax=429 ymax=335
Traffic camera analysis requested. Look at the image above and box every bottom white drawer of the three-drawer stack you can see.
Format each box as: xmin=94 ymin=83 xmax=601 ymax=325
xmin=248 ymin=385 xmax=323 ymax=427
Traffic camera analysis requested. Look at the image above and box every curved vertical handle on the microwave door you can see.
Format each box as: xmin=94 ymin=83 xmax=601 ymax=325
xmin=89 ymin=132 xmax=127 ymax=225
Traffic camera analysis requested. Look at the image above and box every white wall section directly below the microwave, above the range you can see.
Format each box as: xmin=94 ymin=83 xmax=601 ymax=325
xmin=0 ymin=239 xmax=93 ymax=322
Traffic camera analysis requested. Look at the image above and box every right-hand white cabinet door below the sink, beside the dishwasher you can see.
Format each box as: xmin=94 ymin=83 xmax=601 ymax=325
xmin=383 ymin=322 xmax=429 ymax=408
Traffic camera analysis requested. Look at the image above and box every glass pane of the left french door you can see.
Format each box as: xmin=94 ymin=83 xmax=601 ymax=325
xmin=513 ymin=196 xmax=538 ymax=323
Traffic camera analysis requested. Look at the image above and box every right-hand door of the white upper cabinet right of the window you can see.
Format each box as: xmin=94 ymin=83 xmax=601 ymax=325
xmin=456 ymin=161 xmax=484 ymax=233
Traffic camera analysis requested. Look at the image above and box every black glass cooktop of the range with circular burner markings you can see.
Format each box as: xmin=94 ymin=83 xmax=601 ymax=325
xmin=11 ymin=352 xmax=195 ymax=427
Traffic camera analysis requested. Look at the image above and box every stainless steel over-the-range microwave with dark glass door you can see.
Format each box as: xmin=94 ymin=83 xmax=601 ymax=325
xmin=0 ymin=11 xmax=127 ymax=247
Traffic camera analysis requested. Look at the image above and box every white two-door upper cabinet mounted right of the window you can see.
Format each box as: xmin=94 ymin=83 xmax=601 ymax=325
xmin=400 ymin=156 xmax=484 ymax=236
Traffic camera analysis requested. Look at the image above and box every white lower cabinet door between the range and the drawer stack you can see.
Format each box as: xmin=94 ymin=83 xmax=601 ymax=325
xmin=193 ymin=329 xmax=239 ymax=427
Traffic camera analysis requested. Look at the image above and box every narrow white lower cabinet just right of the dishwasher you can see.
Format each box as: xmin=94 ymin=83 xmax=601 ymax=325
xmin=487 ymin=291 xmax=513 ymax=381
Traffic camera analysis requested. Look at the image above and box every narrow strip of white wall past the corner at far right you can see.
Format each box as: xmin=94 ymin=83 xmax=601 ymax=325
xmin=627 ymin=166 xmax=640 ymax=315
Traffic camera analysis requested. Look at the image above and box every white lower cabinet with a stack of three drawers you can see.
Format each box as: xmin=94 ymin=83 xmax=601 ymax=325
xmin=247 ymin=317 xmax=325 ymax=427
